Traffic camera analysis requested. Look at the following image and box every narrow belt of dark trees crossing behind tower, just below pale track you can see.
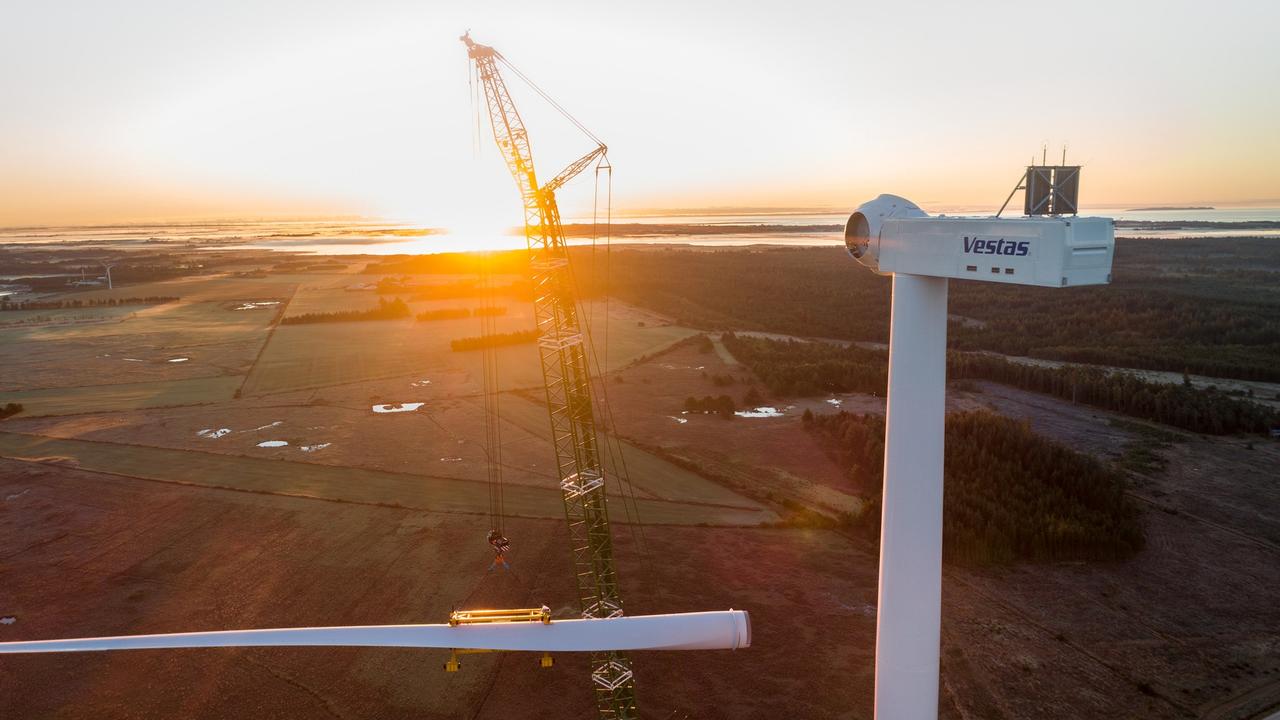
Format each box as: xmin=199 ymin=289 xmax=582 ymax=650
xmin=722 ymin=333 xmax=1280 ymax=434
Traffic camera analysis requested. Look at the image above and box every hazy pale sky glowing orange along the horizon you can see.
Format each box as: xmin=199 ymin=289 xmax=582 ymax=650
xmin=0 ymin=0 xmax=1280 ymax=225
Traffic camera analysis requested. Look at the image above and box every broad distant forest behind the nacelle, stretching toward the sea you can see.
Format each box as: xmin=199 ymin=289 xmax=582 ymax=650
xmin=575 ymin=238 xmax=1280 ymax=382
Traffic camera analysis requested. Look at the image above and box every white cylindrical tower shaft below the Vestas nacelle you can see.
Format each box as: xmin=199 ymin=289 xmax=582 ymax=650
xmin=876 ymin=273 xmax=947 ymax=720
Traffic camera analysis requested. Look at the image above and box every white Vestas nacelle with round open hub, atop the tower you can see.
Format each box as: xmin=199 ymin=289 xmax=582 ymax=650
xmin=845 ymin=195 xmax=1116 ymax=287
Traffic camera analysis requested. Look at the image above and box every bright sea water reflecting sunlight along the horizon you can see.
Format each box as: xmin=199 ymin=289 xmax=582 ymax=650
xmin=0 ymin=208 xmax=1280 ymax=255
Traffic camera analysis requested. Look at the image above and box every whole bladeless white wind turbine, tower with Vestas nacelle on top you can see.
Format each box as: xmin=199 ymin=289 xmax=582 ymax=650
xmin=845 ymin=175 xmax=1115 ymax=720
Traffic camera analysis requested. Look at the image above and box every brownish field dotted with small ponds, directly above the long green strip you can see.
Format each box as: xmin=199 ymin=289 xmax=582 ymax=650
xmin=8 ymin=379 xmax=772 ymax=521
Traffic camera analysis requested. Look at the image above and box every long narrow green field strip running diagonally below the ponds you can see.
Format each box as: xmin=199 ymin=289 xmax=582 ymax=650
xmin=0 ymin=432 xmax=777 ymax=525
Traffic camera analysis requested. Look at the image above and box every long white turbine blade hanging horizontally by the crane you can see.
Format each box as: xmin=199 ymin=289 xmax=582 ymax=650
xmin=0 ymin=610 xmax=751 ymax=653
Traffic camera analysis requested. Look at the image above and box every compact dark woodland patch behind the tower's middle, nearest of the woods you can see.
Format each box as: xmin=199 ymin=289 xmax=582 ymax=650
xmin=805 ymin=411 xmax=1143 ymax=565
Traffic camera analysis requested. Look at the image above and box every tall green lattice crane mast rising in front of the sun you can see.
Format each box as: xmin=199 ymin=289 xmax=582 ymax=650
xmin=461 ymin=33 xmax=637 ymax=720
